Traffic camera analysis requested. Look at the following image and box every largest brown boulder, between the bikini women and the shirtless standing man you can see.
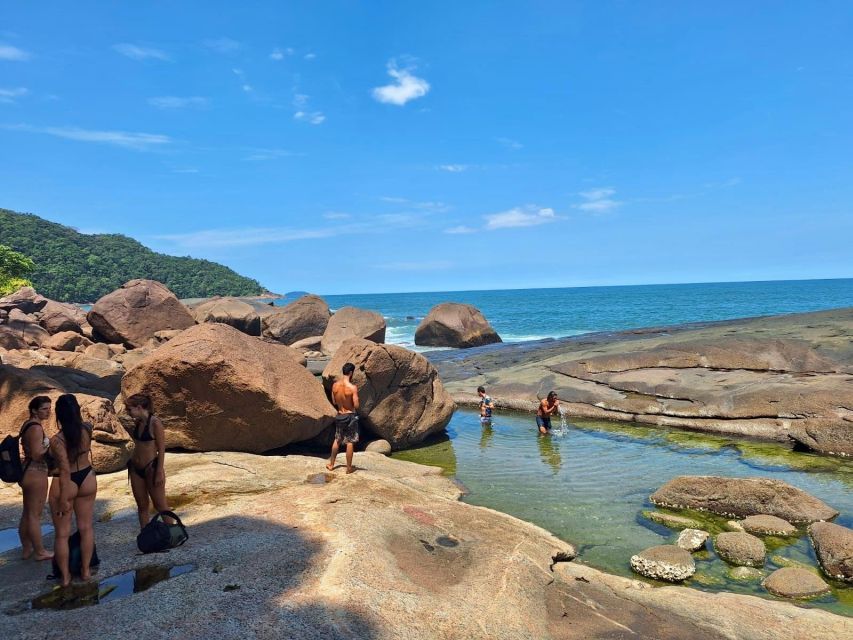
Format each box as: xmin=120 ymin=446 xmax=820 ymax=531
xmin=121 ymin=323 xmax=335 ymax=453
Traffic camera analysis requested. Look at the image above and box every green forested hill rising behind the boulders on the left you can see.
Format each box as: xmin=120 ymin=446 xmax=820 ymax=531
xmin=0 ymin=209 xmax=263 ymax=302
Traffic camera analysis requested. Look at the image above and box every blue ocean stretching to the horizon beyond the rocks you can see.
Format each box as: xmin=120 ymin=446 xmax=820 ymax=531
xmin=298 ymin=278 xmax=853 ymax=348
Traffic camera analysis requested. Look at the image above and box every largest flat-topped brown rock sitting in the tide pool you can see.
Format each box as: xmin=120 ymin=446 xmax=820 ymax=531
xmin=649 ymin=476 xmax=838 ymax=522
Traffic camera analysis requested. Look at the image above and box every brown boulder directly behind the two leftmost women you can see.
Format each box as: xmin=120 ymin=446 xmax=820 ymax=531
xmin=0 ymin=365 xmax=131 ymax=473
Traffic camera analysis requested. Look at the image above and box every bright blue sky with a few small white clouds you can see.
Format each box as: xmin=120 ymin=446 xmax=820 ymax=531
xmin=0 ymin=1 xmax=853 ymax=294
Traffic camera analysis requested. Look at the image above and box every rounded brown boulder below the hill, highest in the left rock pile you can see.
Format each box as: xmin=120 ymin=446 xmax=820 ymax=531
xmin=87 ymin=280 xmax=195 ymax=348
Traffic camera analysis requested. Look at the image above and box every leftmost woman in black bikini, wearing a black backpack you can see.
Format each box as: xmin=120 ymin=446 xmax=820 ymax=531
xmin=18 ymin=396 xmax=53 ymax=560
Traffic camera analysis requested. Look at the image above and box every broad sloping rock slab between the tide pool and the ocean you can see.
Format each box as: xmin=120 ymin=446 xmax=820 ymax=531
xmin=428 ymin=309 xmax=853 ymax=456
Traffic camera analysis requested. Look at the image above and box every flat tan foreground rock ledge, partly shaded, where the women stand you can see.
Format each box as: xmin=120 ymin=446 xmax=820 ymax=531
xmin=0 ymin=452 xmax=853 ymax=640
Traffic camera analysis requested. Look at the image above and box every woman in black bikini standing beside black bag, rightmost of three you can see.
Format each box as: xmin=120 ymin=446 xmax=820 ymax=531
xmin=124 ymin=393 xmax=171 ymax=528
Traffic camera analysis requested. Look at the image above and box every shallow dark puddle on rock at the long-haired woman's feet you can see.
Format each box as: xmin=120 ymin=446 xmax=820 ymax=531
xmin=6 ymin=564 xmax=196 ymax=615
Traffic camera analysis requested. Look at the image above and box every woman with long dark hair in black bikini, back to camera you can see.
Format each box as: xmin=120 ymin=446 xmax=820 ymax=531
xmin=49 ymin=393 xmax=98 ymax=587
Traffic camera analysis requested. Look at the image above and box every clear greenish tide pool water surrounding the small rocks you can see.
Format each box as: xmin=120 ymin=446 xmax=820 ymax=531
xmin=394 ymin=409 xmax=853 ymax=615
